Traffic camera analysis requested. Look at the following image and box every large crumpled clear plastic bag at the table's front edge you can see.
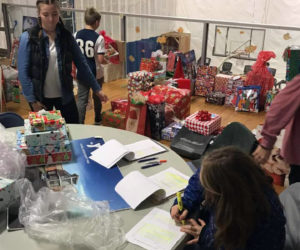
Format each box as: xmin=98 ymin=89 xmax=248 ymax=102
xmin=18 ymin=179 xmax=125 ymax=250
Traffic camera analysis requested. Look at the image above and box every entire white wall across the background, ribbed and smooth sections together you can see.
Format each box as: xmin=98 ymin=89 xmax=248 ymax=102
xmin=0 ymin=0 xmax=300 ymax=79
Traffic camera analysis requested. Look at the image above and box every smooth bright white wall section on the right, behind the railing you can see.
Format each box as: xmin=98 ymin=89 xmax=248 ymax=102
xmin=174 ymin=0 xmax=300 ymax=79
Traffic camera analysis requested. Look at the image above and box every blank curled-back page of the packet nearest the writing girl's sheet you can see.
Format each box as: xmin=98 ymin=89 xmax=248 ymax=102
xmin=115 ymin=171 xmax=165 ymax=209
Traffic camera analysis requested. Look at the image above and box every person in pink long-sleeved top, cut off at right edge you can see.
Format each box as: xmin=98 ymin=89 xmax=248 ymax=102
xmin=253 ymin=74 xmax=300 ymax=185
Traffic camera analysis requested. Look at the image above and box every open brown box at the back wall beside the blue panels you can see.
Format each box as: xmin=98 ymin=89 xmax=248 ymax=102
xmin=161 ymin=32 xmax=191 ymax=55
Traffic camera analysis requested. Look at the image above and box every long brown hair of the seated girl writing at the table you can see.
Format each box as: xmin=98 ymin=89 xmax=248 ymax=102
xmin=200 ymin=146 xmax=272 ymax=249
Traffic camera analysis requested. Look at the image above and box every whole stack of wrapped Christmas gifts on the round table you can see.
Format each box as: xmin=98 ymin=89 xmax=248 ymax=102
xmin=17 ymin=110 xmax=72 ymax=166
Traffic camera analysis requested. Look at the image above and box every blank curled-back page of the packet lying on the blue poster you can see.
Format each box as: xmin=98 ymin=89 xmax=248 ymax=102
xmin=89 ymin=139 xmax=134 ymax=168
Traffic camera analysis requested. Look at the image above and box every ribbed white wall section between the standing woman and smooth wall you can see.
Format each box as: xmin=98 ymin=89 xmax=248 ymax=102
xmin=74 ymin=0 xmax=176 ymax=42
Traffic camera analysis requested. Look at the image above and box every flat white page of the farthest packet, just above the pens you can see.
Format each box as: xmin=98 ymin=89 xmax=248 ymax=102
xmin=125 ymin=139 xmax=167 ymax=160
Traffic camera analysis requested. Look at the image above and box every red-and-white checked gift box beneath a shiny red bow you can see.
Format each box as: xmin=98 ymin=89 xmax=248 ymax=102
xmin=184 ymin=112 xmax=221 ymax=135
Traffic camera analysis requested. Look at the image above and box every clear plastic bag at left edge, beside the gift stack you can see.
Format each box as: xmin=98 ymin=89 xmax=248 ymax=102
xmin=0 ymin=124 xmax=26 ymax=180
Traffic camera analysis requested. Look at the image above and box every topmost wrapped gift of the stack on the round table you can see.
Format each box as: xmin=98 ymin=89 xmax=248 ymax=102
xmin=29 ymin=110 xmax=65 ymax=132
